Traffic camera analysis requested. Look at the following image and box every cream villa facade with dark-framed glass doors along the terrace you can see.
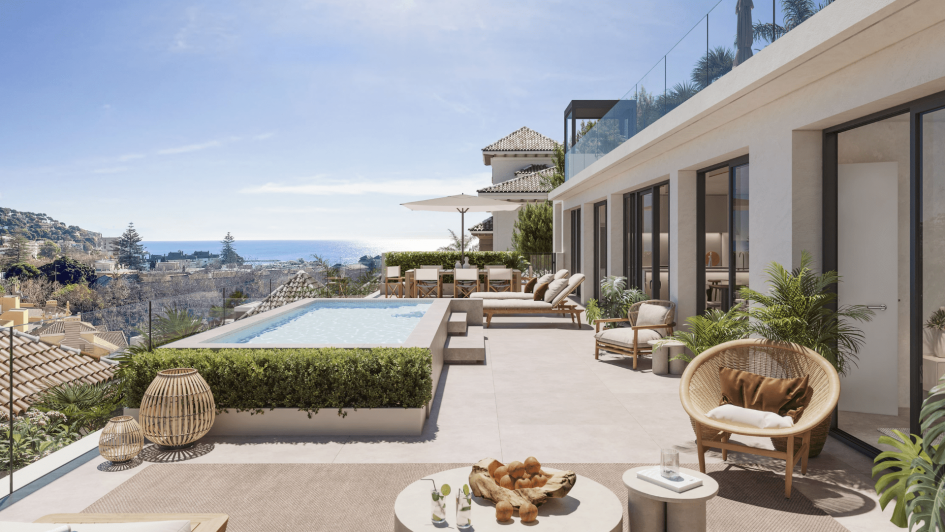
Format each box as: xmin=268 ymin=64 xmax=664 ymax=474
xmin=550 ymin=0 xmax=945 ymax=453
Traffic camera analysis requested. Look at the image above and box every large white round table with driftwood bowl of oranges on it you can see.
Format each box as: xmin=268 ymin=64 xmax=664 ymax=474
xmin=394 ymin=466 xmax=623 ymax=532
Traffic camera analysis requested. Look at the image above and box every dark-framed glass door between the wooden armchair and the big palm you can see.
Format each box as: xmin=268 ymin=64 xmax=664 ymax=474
xmin=696 ymin=157 xmax=749 ymax=314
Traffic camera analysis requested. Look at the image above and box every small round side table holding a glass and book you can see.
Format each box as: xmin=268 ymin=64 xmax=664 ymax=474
xmin=623 ymin=465 xmax=719 ymax=532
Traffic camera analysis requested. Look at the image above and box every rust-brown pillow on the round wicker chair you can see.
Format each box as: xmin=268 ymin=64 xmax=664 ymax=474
xmin=719 ymin=368 xmax=814 ymax=423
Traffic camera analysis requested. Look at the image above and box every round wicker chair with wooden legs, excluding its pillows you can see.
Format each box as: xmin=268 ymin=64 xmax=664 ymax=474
xmin=679 ymin=339 xmax=840 ymax=498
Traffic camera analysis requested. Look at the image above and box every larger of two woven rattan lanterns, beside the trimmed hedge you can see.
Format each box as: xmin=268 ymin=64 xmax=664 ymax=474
xmin=138 ymin=368 xmax=215 ymax=448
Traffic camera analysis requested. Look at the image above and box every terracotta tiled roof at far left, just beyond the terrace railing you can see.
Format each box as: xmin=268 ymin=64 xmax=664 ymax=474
xmin=0 ymin=329 xmax=115 ymax=414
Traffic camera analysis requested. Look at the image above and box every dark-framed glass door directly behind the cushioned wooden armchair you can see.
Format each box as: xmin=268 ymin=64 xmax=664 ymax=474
xmin=623 ymin=183 xmax=670 ymax=299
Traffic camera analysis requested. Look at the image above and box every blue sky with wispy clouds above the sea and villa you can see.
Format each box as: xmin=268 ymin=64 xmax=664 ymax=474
xmin=0 ymin=0 xmax=718 ymax=240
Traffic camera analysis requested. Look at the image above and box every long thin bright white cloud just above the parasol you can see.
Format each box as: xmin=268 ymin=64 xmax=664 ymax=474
xmin=240 ymin=173 xmax=491 ymax=197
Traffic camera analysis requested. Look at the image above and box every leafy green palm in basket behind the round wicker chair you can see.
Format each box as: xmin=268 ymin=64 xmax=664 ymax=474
xmin=739 ymin=251 xmax=873 ymax=457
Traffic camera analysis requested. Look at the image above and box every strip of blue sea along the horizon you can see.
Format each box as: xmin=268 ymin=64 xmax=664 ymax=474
xmin=141 ymin=238 xmax=449 ymax=264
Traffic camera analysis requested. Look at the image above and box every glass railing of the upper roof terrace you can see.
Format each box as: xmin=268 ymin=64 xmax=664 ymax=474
xmin=565 ymin=0 xmax=833 ymax=180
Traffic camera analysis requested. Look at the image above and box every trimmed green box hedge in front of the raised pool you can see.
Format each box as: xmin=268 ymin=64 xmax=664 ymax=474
xmin=119 ymin=347 xmax=433 ymax=416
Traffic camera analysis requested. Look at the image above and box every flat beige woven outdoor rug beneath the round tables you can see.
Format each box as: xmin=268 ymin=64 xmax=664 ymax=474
xmin=84 ymin=463 xmax=846 ymax=532
